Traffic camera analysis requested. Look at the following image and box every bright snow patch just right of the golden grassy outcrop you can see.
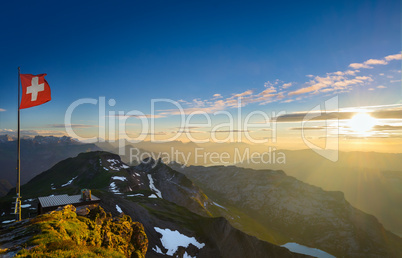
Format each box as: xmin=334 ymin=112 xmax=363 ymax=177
xmin=154 ymin=227 xmax=205 ymax=256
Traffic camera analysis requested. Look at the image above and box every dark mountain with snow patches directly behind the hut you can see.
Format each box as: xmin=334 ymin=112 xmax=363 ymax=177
xmin=0 ymin=152 xmax=306 ymax=257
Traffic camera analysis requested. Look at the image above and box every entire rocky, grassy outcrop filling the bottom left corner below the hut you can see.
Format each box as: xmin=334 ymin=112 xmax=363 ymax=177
xmin=0 ymin=205 xmax=148 ymax=258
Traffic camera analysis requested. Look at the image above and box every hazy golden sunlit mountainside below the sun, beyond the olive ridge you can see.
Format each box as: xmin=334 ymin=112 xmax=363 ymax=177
xmin=236 ymin=150 xmax=402 ymax=236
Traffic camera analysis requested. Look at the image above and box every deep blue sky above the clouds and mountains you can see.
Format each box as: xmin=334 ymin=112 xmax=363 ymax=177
xmin=0 ymin=0 xmax=401 ymax=149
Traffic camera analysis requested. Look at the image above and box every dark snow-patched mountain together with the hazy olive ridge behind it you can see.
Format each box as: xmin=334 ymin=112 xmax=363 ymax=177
xmin=0 ymin=151 xmax=402 ymax=257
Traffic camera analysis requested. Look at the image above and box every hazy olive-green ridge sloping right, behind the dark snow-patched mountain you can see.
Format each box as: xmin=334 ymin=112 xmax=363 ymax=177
xmin=173 ymin=164 xmax=402 ymax=257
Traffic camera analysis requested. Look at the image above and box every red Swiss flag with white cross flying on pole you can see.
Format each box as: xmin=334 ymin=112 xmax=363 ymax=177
xmin=20 ymin=73 xmax=51 ymax=109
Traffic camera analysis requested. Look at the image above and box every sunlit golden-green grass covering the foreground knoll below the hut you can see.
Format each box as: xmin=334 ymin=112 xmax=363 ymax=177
xmin=16 ymin=206 xmax=148 ymax=257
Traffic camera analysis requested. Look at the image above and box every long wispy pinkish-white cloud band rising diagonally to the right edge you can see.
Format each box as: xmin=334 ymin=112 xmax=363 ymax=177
xmin=159 ymin=54 xmax=402 ymax=118
